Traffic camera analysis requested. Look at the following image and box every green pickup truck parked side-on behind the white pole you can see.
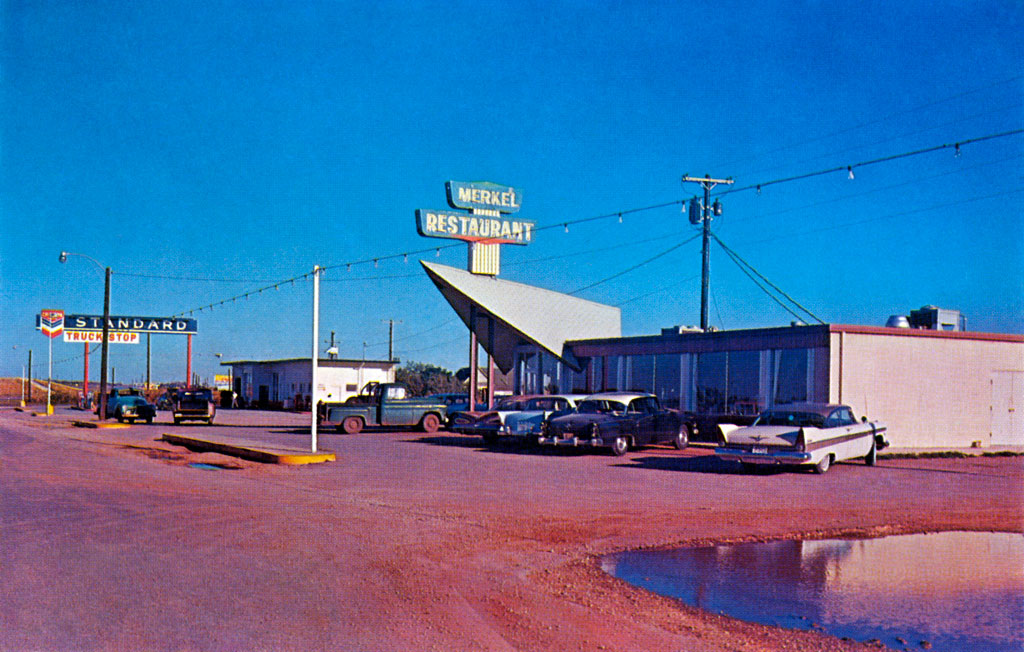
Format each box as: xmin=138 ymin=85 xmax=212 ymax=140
xmin=317 ymin=383 xmax=445 ymax=435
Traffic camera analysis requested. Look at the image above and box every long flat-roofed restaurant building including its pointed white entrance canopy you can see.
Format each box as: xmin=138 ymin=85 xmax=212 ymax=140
xmin=423 ymin=258 xmax=1024 ymax=448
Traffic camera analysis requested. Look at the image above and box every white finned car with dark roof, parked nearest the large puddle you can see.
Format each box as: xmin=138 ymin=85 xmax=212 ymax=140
xmin=715 ymin=403 xmax=889 ymax=473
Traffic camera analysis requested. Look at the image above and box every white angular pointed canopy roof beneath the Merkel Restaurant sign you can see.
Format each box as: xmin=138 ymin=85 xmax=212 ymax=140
xmin=420 ymin=261 xmax=622 ymax=374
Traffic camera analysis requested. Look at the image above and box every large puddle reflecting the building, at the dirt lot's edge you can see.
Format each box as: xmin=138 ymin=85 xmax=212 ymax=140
xmin=602 ymin=532 xmax=1024 ymax=652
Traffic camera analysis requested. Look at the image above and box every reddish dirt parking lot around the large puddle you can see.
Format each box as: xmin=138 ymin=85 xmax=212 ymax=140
xmin=0 ymin=409 xmax=1024 ymax=651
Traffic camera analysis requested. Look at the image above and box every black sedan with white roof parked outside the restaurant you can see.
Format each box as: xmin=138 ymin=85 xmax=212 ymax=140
xmin=538 ymin=392 xmax=689 ymax=455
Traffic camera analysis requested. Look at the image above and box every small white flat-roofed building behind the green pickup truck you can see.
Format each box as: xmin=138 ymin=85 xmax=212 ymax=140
xmin=221 ymin=358 xmax=398 ymax=409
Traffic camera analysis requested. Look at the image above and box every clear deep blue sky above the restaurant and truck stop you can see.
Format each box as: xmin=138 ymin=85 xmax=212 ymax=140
xmin=0 ymin=0 xmax=1024 ymax=381
